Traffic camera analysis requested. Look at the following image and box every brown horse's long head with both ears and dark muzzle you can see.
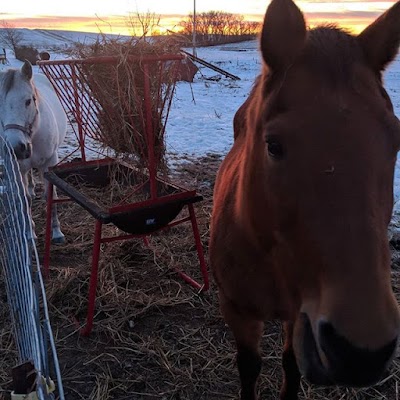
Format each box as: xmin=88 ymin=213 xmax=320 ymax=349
xmin=244 ymin=0 xmax=400 ymax=386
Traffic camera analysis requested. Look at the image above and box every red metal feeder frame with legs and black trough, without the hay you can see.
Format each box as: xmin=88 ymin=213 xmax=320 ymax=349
xmin=38 ymin=55 xmax=209 ymax=335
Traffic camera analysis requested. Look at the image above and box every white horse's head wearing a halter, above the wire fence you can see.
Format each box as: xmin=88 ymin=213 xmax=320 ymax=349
xmin=0 ymin=61 xmax=38 ymax=160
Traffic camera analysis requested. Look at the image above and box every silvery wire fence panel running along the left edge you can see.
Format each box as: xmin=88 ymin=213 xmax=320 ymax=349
xmin=0 ymin=137 xmax=64 ymax=400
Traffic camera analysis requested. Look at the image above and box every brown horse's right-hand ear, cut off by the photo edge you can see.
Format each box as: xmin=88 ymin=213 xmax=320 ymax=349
xmin=358 ymin=1 xmax=400 ymax=72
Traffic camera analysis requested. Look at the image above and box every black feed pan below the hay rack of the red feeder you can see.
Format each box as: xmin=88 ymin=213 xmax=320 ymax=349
xmin=45 ymin=160 xmax=203 ymax=235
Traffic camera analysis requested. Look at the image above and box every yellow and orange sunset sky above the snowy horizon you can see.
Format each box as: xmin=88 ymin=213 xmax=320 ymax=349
xmin=0 ymin=0 xmax=394 ymax=34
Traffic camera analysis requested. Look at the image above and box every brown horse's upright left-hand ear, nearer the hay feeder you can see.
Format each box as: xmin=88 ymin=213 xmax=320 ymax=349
xmin=261 ymin=0 xmax=306 ymax=71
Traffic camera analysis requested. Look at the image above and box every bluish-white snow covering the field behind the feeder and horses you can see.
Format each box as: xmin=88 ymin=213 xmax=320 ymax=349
xmin=0 ymin=30 xmax=400 ymax=211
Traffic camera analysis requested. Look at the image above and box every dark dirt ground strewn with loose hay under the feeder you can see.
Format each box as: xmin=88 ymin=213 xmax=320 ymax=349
xmin=0 ymin=155 xmax=400 ymax=400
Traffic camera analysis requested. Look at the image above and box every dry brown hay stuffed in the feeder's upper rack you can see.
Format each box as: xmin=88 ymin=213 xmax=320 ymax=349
xmin=72 ymin=39 xmax=179 ymax=171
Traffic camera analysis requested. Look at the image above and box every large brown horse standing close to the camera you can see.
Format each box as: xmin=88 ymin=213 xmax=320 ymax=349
xmin=210 ymin=0 xmax=400 ymax=400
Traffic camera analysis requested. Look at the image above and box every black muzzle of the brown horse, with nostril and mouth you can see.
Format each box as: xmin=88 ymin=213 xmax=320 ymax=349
xmin=294 ymin=313 xmax=398 ymax=387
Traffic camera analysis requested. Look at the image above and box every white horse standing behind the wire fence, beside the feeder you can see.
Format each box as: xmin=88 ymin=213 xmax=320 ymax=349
xmin=0 ymin=61 xmax=67 ymax=243
